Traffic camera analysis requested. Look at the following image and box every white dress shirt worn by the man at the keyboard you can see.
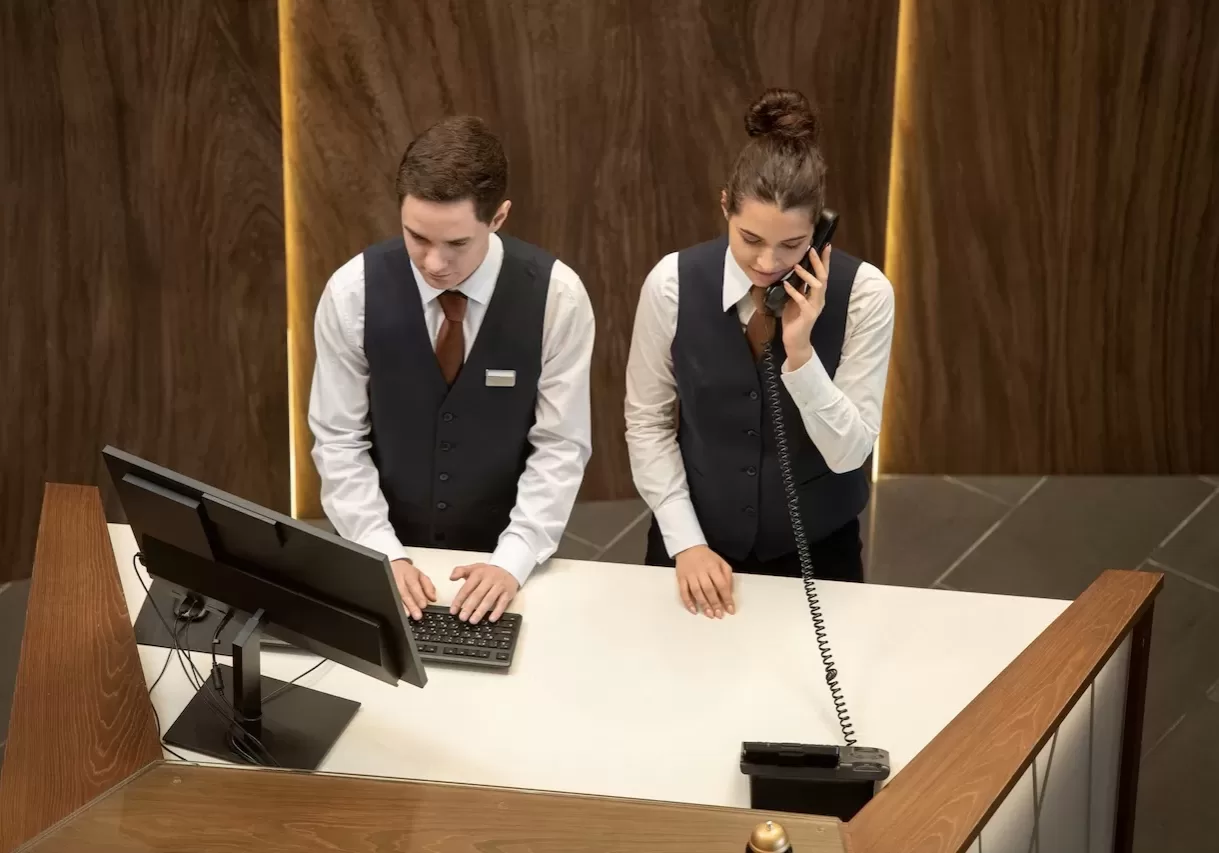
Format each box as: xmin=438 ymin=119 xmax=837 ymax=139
xmin=308 ymin=234 xmax=595 ymax=584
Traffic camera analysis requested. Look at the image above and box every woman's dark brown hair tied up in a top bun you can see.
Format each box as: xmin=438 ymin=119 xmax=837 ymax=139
xmin=725 ymin=89 xmax=825 ymax=218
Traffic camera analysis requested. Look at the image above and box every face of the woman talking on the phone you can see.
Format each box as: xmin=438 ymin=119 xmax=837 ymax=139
xmin=722 ymin=199 xmax=813 ymax=288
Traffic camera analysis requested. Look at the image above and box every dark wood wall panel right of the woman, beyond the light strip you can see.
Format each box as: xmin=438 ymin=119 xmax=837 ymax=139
xmin=880 ymin=0 xmax=1219 ymax=474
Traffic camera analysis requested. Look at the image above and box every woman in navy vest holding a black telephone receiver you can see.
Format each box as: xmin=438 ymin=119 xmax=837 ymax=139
xmin=625 ymin=89 xmax=894 ymax=618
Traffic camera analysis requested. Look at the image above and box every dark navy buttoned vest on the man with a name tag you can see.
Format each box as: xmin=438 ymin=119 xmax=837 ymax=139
xmin=364 ymin=236 xmax=555 ymax=551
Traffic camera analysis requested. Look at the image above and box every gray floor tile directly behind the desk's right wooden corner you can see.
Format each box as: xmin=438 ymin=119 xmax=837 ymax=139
xmin=946 ymin=476 xmax=1213 ymax=598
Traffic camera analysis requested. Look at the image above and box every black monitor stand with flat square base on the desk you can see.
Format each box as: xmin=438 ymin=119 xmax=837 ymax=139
xmin=165 ymin=609 xmax=360 ymax=770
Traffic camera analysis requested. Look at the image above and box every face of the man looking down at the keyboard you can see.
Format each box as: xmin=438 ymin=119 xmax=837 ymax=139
xmin=401 ymin=195 xmax=512 ymax=290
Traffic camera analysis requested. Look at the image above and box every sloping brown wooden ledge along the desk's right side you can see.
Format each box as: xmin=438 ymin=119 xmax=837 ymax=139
xmin=847 ymin=572 xmax=1164 ymax=853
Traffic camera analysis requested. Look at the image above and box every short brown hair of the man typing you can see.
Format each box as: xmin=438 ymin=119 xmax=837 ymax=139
xmin=397 ymin=116 xmax=508 ymax=222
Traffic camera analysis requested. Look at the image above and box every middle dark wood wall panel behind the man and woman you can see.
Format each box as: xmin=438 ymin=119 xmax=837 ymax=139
xmin=280 ymin=0 xmax=897 ymax=517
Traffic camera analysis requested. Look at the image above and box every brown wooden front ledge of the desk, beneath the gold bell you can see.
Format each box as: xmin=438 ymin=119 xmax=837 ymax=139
xmin=14 ymin=763 xmax=845 ymax=853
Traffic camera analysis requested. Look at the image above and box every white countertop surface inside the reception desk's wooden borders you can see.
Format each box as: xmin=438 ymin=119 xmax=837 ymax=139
xmin=110 ymin=524 xmax=1069 ymax=807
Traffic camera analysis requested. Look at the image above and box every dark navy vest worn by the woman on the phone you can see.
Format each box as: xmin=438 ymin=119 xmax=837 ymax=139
xmin=673 ymin=238 xmax=869 ymax=561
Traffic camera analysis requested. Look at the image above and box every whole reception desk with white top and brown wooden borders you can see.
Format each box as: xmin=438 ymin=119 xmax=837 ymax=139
xmin=0 ymin=486 xmax=1162 ymax=853
